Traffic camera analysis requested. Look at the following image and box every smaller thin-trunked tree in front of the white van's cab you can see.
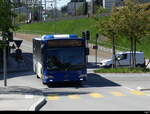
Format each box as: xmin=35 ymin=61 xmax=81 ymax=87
xmin=94 ymin=8 xmax=120 ymax=68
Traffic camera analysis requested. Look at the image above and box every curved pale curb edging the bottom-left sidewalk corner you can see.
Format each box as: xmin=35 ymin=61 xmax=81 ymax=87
xmin=29 ymin=97 xmax=47 ymax=111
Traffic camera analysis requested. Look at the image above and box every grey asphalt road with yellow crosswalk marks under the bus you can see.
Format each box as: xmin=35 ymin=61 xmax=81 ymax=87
xmin=8 ymin=38 xmax=150 ymax=111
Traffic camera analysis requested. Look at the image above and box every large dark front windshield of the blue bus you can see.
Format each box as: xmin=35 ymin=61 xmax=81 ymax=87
xmin=46 ymin=47 xmax=85 ymax=71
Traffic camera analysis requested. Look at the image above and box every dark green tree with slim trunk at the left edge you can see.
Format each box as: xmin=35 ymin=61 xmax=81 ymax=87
xmin=0 ymin=0 xmax=16 ymax=86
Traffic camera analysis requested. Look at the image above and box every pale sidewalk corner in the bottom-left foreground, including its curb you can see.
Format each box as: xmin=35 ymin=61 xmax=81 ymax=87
xmin=0 ymin=86 xmax=46 ymax=111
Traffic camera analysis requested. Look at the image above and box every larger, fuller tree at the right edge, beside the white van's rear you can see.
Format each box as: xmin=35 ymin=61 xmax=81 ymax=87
xmin=113 ymin=0 xmax=150 ymax=68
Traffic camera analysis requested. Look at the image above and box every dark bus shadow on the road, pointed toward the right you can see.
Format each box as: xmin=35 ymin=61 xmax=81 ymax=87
xmin=48 ymin=73 xmax=121 ymax=88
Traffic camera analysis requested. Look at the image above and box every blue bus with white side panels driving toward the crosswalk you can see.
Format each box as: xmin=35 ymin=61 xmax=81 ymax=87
xmin=33 ymin=34 xmax=89 ymax=84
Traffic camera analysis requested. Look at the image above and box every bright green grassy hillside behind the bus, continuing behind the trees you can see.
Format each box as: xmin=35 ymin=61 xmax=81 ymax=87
xmin=17 ymin=17 xmax=150 ymax=58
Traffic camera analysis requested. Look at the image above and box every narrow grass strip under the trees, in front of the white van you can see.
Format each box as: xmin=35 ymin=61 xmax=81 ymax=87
xmin=94 ymin=68 xmax=150 ymax=73
